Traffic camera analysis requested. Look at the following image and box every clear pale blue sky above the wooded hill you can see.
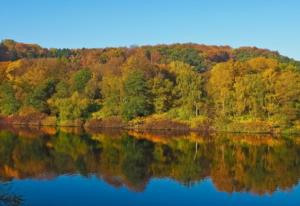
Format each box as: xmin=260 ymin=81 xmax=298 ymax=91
xmin=0 ymin=0 xmax=300 ymax=60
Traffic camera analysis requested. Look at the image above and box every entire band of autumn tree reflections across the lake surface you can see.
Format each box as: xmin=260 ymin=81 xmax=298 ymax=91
xmin=0 ymin=131 xmax=300 ymax=194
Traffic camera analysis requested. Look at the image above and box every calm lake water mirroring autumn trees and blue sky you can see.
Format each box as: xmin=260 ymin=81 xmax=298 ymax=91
xmin=0 ymin=128 xmax=300 ymax=206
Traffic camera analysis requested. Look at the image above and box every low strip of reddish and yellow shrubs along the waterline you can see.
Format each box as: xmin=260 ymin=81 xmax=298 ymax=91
xmin=0 ymin=114 xmax=300 ymax=134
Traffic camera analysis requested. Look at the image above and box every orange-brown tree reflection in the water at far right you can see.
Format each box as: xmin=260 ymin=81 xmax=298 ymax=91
xmin=211 ymin=137 xmax=300 ymax=194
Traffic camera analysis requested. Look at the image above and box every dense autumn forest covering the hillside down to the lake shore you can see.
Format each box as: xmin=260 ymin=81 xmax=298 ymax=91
xmin=0 ymin=40 xmax=300 ymax=132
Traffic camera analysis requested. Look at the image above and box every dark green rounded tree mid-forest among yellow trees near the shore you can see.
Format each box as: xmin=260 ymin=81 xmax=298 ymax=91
xmin=121 ymin=70 xmax=152 ymax=120
